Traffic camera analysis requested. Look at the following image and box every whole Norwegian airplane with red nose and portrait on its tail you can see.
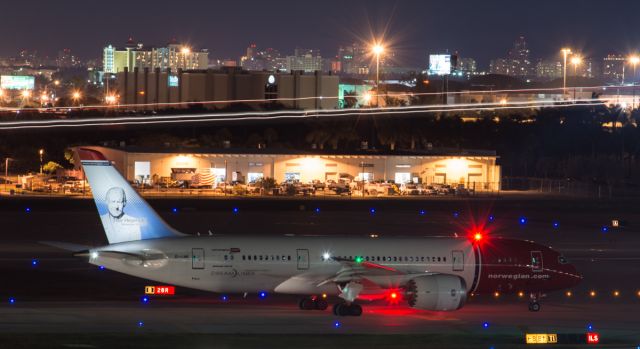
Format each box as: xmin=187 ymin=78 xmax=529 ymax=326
xmin=76 ymin=148 xmax=582 ymax=316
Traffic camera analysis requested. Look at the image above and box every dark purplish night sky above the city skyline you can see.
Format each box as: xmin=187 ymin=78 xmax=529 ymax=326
xmin=0 ymin=0 xmax=640 ymax=68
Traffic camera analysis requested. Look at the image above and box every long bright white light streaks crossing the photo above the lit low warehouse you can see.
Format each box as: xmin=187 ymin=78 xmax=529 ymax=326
xmin=0 ymin=102 xmax=605 ymax=130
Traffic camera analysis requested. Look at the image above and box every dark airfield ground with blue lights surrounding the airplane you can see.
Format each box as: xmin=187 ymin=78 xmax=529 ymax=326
xmin=0 ymin=198 xmax=640 ymax=348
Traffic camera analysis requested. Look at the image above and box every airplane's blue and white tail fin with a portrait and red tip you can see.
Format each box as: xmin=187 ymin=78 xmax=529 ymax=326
xmin=77 ymin=148 xmax=184 ymax=244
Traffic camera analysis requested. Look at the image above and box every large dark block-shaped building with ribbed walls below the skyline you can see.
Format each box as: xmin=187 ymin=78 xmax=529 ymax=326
xmin=116 ymin=68 xmax=339 ymax=110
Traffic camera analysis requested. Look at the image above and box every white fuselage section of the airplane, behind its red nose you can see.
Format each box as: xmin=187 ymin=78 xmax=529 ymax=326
xmin=90 ymin=236 xmax=480 ymax=295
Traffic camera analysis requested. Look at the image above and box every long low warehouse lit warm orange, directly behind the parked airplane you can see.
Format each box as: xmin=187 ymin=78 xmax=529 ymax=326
xmin=77 ymin=147 xmax=500 ymax=191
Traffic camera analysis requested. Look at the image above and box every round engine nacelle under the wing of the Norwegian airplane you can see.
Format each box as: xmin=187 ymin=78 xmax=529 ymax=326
xmin=405 ymin=275 xmax=467 ymax=311
